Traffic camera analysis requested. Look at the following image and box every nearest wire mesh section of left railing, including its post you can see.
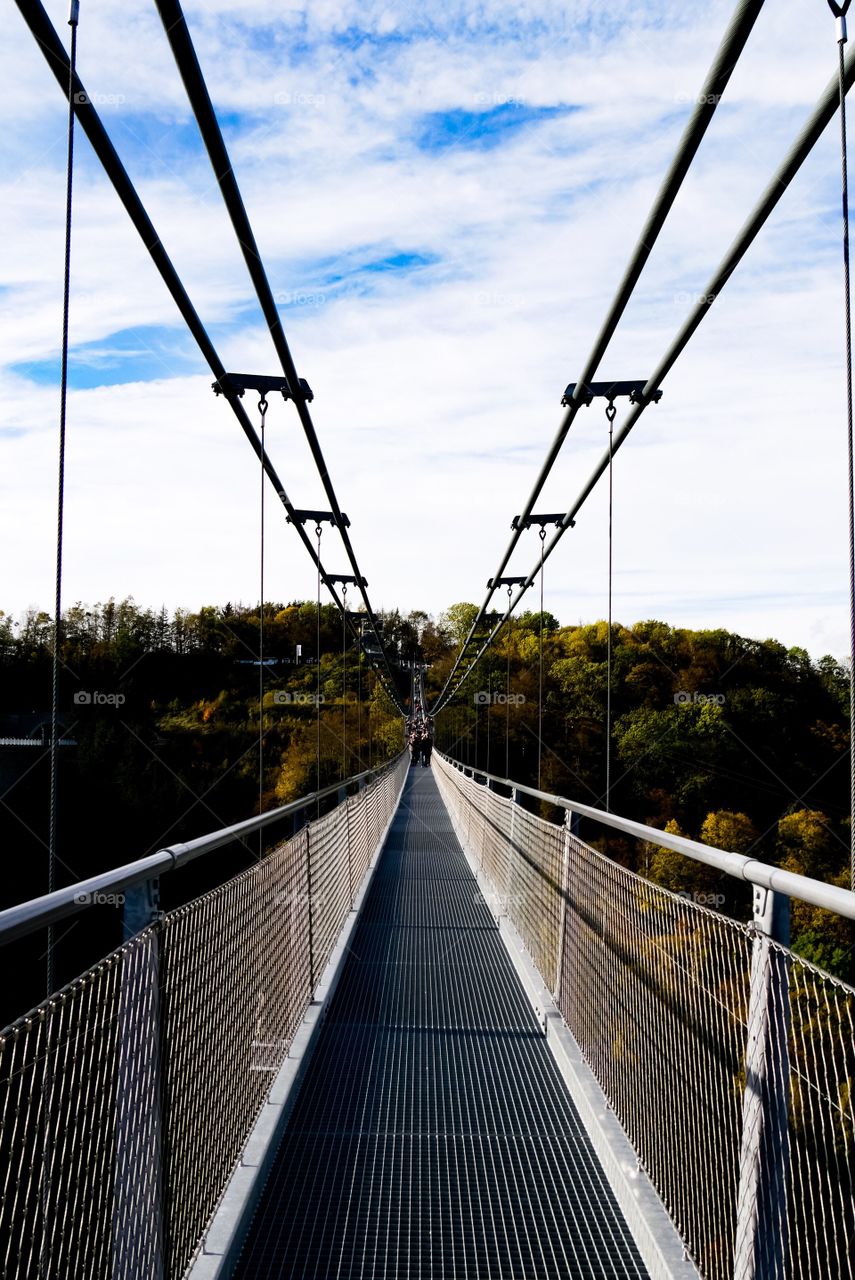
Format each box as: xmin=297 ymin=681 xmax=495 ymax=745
xmin=0 ymin=931 xmax=161 ymax=1280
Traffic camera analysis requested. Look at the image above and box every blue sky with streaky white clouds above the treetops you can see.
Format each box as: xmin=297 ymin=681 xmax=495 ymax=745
xmin=0 ymin=0 xmax=849 ymax=657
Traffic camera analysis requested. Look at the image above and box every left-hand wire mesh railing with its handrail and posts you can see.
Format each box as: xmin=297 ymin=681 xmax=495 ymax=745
xmin=0 ymin=754 xmax=407 ymax=1280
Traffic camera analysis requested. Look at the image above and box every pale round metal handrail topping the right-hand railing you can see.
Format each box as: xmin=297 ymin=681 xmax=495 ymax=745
xmin=438 ymin=751 xmax=855 ymax=920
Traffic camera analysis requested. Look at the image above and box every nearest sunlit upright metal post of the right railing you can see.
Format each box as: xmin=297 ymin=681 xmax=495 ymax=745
xmin=733 ymin=887 xmax=790 ymax=1280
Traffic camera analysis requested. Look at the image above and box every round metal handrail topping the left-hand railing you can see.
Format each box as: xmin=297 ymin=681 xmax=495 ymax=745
xmin=0 ymin=751 xmax=403 ymax=946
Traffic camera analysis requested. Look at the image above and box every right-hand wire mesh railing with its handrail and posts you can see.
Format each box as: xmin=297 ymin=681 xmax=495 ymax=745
xmin=434 ymin=753 xmax=855 ymax=1280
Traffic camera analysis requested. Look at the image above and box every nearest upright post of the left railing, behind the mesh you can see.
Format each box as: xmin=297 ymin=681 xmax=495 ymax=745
xmin=110 ymin=877 xmax=165 ymax=1280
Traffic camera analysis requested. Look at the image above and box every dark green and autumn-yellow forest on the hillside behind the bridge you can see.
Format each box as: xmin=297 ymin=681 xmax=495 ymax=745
xmin=0 ymin=599 xmax=851 ymax=1013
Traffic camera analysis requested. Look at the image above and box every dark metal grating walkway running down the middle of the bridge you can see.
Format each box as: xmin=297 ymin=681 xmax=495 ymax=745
xmin=236 ymin=768 xmax=648 ymax=1280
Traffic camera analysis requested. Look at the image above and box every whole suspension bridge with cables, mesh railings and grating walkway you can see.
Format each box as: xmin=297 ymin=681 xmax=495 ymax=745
xmin=0 ymin=0 xmax=855 ymax=1280
